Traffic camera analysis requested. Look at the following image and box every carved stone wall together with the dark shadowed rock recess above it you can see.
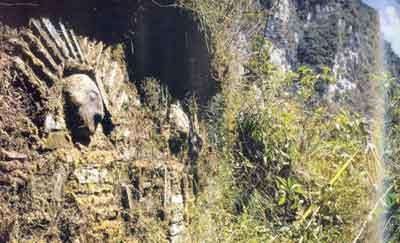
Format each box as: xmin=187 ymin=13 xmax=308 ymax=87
xmin=0 ymin=1 xmax=212 ymax=242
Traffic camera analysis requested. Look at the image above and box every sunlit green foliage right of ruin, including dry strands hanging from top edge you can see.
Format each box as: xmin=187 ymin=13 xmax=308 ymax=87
xmin=186 ymin=1 xmax=377 ymax=243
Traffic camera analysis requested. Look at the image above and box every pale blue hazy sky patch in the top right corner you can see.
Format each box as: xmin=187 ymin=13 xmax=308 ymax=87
xmin=363 ymin=0 xmax=400 ymax=56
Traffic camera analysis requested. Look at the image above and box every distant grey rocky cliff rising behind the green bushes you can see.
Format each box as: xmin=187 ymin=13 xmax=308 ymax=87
xmin=265 ymin=0 xmax=394 ymax=107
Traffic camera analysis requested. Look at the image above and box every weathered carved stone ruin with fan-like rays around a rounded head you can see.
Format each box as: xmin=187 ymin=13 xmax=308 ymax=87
xmin=0 ymin=13 xmax=201 ymax=243
